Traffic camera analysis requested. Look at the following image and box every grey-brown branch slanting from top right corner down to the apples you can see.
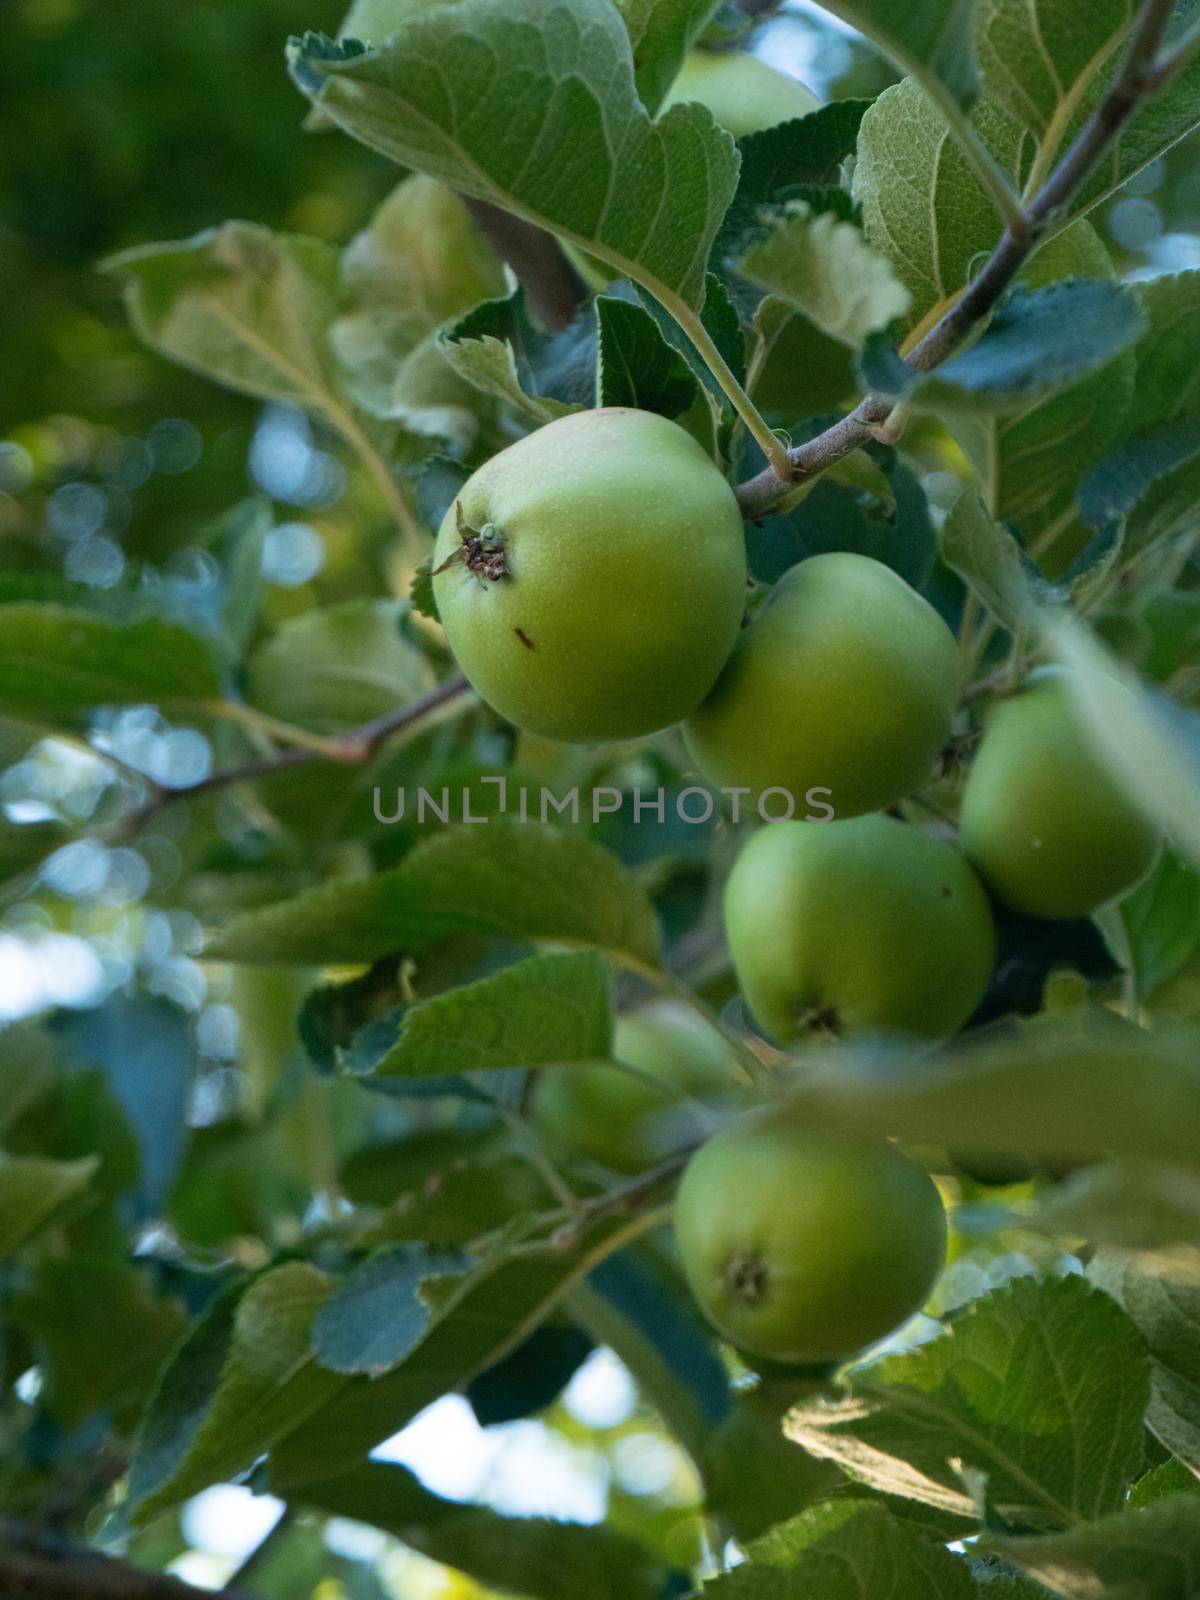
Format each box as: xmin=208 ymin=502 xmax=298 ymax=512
xmin=736 ymin=0 xmax=1189 ymax=518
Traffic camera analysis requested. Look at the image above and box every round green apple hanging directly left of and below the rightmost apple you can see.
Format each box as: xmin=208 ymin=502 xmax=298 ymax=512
xmin=725 ymin=816 xmax=995 ymax=1043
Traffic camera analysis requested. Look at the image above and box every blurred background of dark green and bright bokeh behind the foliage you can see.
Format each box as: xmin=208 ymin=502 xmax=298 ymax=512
xmin=0 ymin=0 xmax=1200 ymax=1600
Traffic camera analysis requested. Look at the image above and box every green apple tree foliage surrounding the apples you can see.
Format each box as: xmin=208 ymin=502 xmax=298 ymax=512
xmin=0 ymin=0 xmax=1200 ymax=1600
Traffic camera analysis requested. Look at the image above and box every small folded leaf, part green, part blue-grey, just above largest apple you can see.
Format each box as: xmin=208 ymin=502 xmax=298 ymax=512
xmin=438 ymin=288 xmax=597 ymax=427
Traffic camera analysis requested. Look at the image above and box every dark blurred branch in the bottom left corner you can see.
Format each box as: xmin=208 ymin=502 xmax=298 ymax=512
xmin=0 ymin=1518 xmax=254 ymax=1600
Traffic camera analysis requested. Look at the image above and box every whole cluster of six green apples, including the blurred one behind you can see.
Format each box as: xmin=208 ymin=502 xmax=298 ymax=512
xmin=434 ymin=390 xmax=1158 ymax=1363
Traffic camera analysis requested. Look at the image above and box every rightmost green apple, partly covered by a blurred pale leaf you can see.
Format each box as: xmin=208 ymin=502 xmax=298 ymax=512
xmin=962 ymin=670 xmax=1162 ymax=918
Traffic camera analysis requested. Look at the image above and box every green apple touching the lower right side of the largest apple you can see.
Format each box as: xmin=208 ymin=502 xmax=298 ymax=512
xmin=683 ymin=550 xmax=960 ymax=818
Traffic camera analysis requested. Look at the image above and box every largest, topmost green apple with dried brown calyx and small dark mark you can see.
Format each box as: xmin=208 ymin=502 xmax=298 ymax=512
xmin=434 ymin=406 xmax=746 ymax=742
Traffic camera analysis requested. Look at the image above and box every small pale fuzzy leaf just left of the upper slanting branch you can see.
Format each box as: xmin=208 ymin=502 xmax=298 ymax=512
xmin=738 ymin=200 xmax=909 ymax=349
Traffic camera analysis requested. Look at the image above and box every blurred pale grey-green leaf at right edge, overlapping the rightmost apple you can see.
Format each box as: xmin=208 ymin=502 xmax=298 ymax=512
xmin=1043 ymin=614 xmax=1200 ymax=866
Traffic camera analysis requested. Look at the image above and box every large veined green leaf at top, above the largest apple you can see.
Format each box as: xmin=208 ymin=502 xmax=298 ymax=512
xmin=288 ymin=0 xmax=738 ymax=312
